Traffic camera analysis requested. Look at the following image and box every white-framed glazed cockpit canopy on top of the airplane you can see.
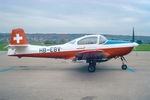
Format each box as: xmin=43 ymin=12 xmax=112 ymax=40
xmin=68 ymin=35 xmax=107 ymax=45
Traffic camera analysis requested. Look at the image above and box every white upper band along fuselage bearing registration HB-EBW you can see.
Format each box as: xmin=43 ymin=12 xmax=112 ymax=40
xmin=8 ymin=43 xmax=137 ymax=55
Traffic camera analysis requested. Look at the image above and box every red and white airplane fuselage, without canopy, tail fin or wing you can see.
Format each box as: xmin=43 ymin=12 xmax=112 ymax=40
xmin=8 ymin=41 xmax=136 ymax=59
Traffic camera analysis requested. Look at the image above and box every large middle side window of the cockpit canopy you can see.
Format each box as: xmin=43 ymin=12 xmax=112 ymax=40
xmin=78 ymin=36 xmax=97 ymax=45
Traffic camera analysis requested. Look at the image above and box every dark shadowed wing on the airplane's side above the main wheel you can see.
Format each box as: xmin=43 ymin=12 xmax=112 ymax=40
xmin=75 ymin=50 xmax=110 ymax=60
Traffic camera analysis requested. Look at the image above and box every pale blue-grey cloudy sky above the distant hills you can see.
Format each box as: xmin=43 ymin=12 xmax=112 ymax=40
xmin=0 ymin=0 xmax=150 ymax=36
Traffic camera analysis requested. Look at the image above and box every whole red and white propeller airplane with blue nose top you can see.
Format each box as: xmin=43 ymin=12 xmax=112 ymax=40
xmin=7 ymin=28 xmax=138 ymax=72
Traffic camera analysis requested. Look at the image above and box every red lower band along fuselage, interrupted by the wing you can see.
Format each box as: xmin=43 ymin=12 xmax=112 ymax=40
xmin=9 ymin=47 xmax=133 ymax=59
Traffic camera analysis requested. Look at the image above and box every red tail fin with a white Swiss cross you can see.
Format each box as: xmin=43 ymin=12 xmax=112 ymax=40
xmin=10 ymin=28 xmax=29 ymax=45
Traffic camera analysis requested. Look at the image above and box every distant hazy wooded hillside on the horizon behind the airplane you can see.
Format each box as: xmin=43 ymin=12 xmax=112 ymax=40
xmin=0 ymin=33 xmax=150 ymax=44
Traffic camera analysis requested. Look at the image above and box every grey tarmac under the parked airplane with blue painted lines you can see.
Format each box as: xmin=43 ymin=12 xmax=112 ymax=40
xmin=0 ymin=52 xmax=150 ymax=100
